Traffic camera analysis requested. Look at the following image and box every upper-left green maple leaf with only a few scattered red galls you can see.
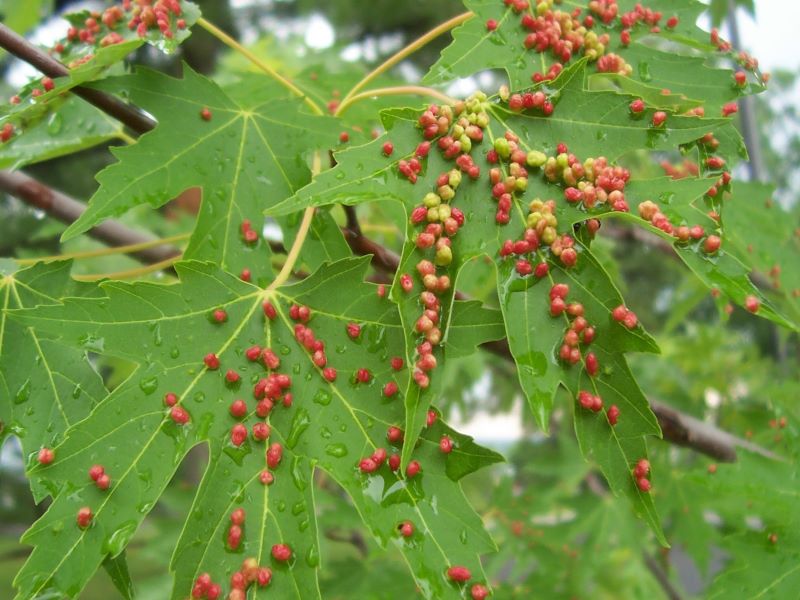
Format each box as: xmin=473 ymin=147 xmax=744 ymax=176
xmin=58 ymin=68 xmax=336 ymax=282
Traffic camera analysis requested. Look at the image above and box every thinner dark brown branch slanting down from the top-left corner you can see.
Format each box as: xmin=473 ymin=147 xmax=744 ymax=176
xmin=0 ymin=23 xmax=156 ymax=133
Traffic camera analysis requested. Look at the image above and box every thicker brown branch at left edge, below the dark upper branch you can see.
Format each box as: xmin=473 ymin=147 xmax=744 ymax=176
xmin=0 ymin=171 xmax=181 ymax=264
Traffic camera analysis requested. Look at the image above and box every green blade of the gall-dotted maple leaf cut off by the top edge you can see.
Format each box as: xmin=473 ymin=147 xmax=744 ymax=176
xmin=423 ymin=0 xmax=763 ymax=115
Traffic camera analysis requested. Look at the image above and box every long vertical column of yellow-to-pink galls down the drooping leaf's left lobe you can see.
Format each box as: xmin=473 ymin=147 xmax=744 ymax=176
xmin=404 ymin=92 xmax=489 ymax=388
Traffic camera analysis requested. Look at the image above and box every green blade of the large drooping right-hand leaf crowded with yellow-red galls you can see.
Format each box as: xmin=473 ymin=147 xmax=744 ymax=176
xmin=272 ymin=63 xmax=764 ymax=540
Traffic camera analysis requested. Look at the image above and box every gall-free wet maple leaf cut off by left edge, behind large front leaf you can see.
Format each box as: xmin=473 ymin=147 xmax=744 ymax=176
xmin=0 ymin=262 xmax=107 ymax=490
